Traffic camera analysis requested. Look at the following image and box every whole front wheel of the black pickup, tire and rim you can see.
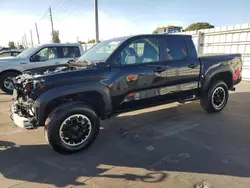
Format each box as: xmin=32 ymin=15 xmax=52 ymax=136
xmin=45 ymin=102 xmax=100 ymax=154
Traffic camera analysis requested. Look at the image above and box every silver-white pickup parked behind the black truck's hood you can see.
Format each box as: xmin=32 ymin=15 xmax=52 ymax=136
xmin=0 ymin=44 xmax=83 ymax=93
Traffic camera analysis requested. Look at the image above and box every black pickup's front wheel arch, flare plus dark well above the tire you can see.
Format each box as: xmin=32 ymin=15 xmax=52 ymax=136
xmin=35 ymin=83 xmax=112 ymax=125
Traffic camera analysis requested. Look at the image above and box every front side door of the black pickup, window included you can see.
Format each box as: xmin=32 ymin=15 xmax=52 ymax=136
xmin=111 ymin=36 xmax=167 ymax=108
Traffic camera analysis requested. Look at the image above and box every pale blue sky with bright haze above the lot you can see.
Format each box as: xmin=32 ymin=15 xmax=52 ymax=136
xmin=0 ymin=0 xmax=250 ymax=46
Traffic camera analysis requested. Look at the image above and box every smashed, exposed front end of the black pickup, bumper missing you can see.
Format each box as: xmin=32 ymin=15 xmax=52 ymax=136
xmin=11 ymin=66 xmax=82 ymax=129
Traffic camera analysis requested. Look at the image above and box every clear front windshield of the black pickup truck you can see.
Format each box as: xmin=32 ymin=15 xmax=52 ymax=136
xmin=76 ymin=37 xmax=126 ymax=63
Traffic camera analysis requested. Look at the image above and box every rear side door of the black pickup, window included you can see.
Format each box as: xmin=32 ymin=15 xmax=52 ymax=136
xmin=164 ymin=35 xmax=200 ymax=92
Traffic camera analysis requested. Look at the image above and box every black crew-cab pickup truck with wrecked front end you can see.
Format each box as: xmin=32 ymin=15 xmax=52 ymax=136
xmin=11 ymin=35 xmax=242 ymax=153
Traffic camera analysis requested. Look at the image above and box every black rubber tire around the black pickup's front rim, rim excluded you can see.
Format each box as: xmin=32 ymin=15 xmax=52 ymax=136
xmin=44 ymin=102 xmax=100 ymax=154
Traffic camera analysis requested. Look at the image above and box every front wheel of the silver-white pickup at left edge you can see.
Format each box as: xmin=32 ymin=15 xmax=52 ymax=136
xmin=0 ymin=71 xmax=20 ymax=94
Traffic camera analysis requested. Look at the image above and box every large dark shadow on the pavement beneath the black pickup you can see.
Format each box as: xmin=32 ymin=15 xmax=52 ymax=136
xmin=0 ymin=92 xmax=250 ymax=187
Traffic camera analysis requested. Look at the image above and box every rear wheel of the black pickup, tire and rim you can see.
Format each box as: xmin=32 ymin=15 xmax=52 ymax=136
xmin=200 ymin=81 xmax=229 ymax=113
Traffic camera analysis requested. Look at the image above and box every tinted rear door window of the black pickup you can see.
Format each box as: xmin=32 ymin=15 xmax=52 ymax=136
xmin=165 ymin=36 xmax=188 ymax=60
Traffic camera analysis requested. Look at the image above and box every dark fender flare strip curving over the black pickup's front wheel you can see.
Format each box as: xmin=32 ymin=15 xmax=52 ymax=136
xmin=35 ymin=82 xmax=112 ymax=125
